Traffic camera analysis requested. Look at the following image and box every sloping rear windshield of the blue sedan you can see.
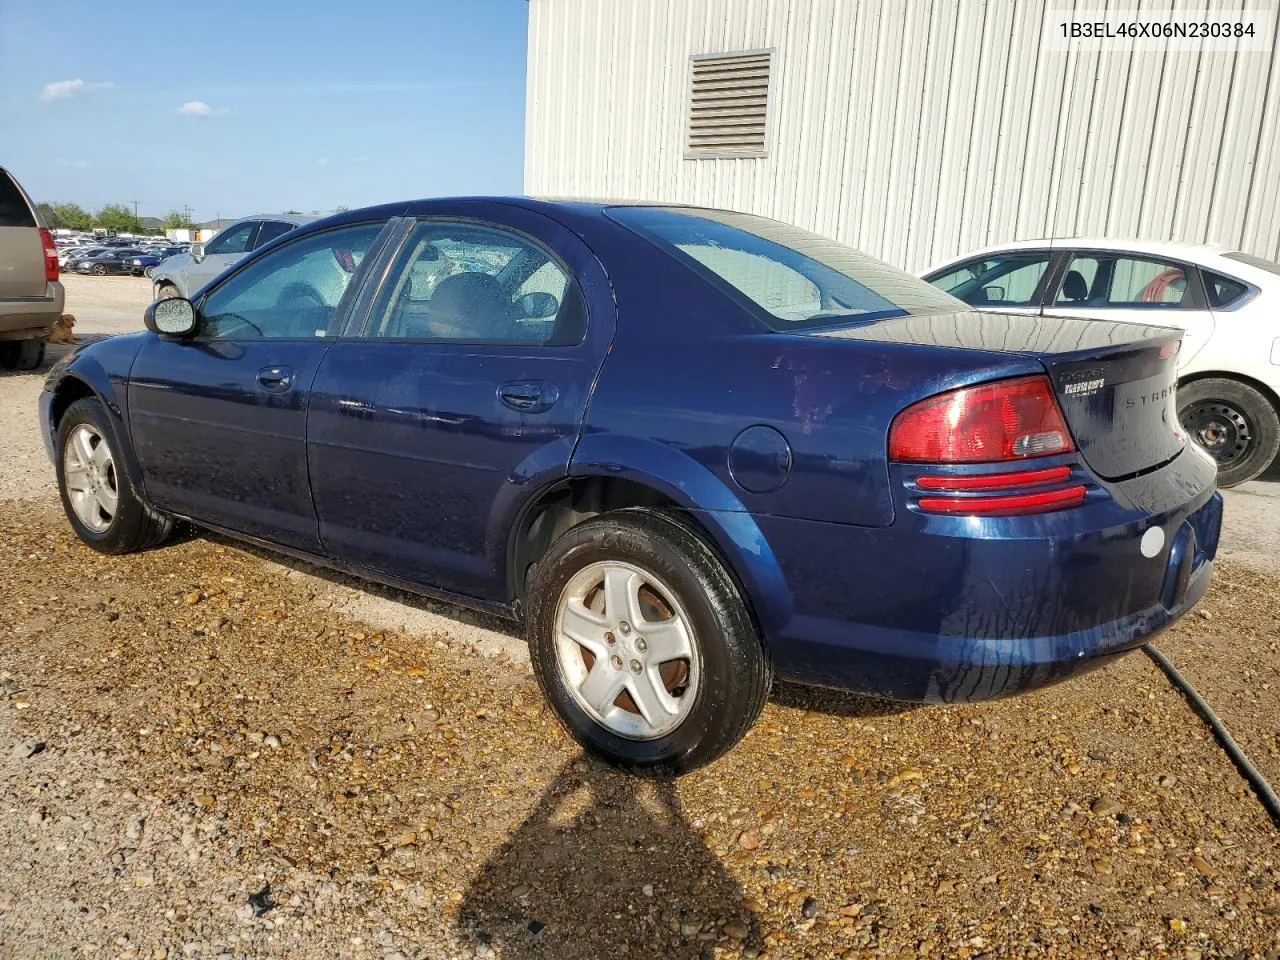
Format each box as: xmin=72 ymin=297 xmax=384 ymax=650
xmin=608 ymin=206 xmax=969 ymax=332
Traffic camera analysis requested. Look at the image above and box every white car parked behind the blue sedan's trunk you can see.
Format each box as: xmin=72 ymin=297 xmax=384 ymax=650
xmin=923 ymin=238 xmax=1280 ymax=486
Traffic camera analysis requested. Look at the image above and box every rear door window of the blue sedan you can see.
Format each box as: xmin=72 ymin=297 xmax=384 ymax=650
xmin=370 ymin=220 xmax=586 ymax=346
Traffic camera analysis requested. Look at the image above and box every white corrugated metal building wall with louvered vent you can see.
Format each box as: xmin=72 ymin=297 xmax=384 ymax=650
xmin=525 ymin=0 xmax=1280 ymax=270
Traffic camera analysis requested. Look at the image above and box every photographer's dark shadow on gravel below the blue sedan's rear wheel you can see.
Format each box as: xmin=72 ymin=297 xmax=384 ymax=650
xmin=457 ymin=760 xmax=760 ymax=960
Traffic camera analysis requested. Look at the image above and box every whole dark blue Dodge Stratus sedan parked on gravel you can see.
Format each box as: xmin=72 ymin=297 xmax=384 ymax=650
xmin=40 ymin=198 xmax=1221 ymax=772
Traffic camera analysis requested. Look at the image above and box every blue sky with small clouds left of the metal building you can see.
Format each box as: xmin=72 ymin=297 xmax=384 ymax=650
xmin=0 ymin=0 xmax=529 ymax=220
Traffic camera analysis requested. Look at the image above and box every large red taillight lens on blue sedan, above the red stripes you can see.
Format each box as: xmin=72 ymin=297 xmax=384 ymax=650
xmin=888 ymin=376 xmax=1075 ymax=463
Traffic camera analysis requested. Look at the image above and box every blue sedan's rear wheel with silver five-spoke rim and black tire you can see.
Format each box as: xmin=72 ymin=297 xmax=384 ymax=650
xmin=527 ymin=509 xmax=773 ymax=773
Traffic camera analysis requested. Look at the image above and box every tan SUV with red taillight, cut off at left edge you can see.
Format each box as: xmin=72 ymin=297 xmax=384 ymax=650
xmin=0 ymin=166 xmax=65 ymax=370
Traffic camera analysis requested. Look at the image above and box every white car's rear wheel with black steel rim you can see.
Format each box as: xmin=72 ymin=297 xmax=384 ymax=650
xmin=1178 ymin=378 xmax=1280 ymax=486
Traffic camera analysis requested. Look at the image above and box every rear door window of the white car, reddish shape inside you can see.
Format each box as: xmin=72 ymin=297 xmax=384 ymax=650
xmin=1055 ymin=253 xmax=1187 ymax=310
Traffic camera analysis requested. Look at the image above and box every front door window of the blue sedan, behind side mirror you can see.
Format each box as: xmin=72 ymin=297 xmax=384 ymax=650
xmin=200 ymin=223 xmax=383 ymax=340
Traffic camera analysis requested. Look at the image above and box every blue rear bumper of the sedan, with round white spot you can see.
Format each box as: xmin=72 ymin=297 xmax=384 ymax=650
xmin=760 ymin=453 xmax=1222 ymax=701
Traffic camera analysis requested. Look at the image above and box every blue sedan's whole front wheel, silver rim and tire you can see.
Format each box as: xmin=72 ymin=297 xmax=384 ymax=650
xmin=55 ymin=398 xmax=173 ymax=553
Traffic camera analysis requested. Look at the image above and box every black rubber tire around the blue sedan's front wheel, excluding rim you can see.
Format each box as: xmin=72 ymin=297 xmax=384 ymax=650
xmin=55 ymin=397 xmax=173 ymax=554
